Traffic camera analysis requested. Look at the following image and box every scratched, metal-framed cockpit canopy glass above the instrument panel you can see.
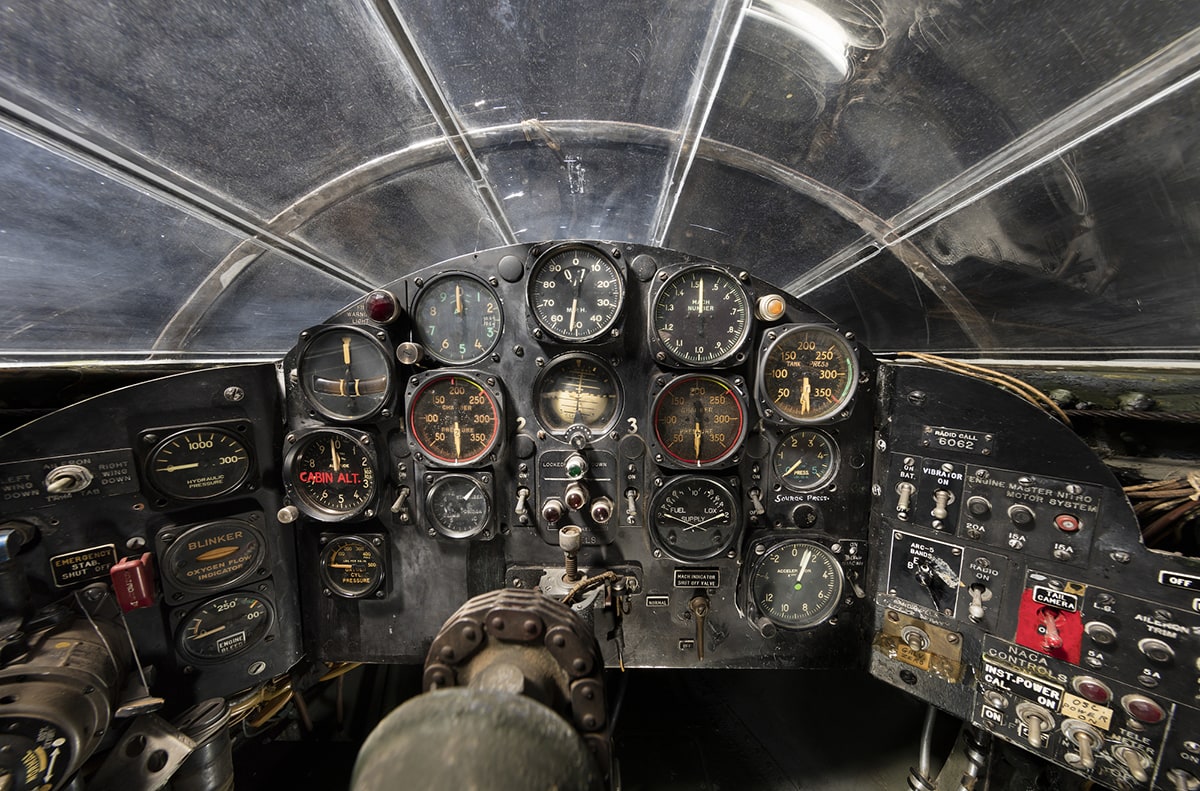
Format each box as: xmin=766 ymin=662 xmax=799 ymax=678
xmin=0 ymin=0 xmax=1200 ymax=362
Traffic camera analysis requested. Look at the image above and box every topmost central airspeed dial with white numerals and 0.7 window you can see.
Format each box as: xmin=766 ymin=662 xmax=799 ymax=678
xmin=529 ymin=247 xmax=625 ymax=341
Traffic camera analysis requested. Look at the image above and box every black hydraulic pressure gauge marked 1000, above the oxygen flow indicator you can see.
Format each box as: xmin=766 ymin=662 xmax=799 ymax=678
xmin=146 ymin=426 xmax=250 ymax=499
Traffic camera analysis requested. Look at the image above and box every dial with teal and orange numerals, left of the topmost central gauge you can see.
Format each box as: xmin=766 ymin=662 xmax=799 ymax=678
xmin=413 ymin=274 xmax=504 ymax=365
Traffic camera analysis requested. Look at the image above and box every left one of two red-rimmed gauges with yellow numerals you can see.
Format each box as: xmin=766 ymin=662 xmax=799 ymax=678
xmin=408 ymin=373 xmax=500 ymax=467
